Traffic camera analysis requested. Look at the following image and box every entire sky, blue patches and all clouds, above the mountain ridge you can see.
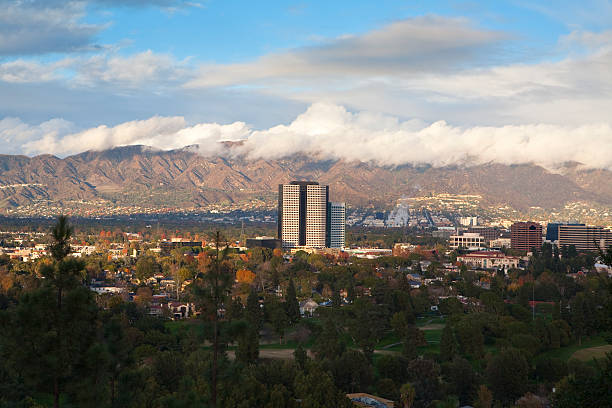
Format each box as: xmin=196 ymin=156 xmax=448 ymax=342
xmin=0 ymin=0 xmax=612 ymax=169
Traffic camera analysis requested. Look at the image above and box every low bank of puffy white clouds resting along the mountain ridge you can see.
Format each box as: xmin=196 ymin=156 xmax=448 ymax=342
xmin=7 ymin=103 xmax=612 ymax=170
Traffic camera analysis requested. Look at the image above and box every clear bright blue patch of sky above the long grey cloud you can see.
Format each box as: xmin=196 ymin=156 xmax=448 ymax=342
xmin=84 ymin=0 xmax=564 ymax=63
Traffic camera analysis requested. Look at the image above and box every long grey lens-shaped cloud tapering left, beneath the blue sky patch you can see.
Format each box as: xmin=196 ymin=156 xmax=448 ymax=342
xmin=187 ymin=16 xmax=506 ymax=87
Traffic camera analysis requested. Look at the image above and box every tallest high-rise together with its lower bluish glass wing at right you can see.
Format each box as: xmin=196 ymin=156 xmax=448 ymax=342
xmin=278 ymin=181 xmax=346 ymax=248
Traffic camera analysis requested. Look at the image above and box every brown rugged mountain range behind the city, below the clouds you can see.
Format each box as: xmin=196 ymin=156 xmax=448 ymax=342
xmin=0 ymin=146 xmax=612 ymax=218
